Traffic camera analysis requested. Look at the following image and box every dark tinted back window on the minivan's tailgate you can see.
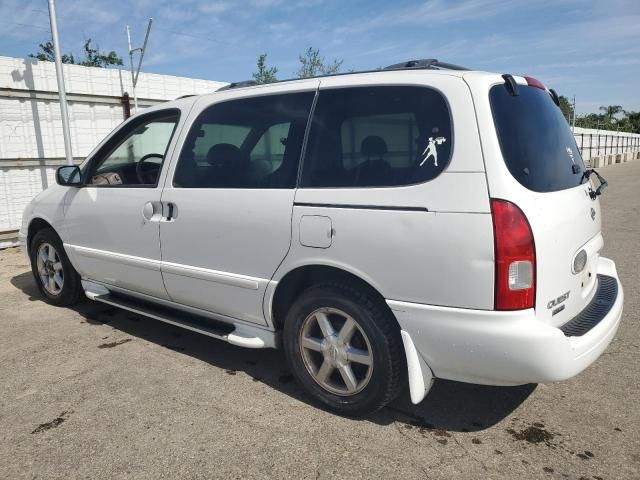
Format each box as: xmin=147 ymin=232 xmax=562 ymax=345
xmin=489 ymin=85 xmax=584 ymax=192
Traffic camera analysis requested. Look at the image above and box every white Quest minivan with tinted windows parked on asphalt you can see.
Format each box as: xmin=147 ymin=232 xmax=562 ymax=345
xmin=20 ymin=60 xmax=623 ymax=415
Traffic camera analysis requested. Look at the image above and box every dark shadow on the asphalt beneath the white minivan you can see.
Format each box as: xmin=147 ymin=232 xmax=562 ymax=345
xmin=11 ymin=272 xmax=536 ymax=432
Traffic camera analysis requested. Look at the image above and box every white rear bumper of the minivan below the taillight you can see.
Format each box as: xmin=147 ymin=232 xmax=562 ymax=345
xmin=387 ymin=258 xmax=624 ymax=385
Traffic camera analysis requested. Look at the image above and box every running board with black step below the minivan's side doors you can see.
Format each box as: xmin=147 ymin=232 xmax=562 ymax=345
xmin=87 ymin=293 xmax=276 ymax=348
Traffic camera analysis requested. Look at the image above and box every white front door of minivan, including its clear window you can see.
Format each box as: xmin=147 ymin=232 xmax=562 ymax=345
xmin=64 ymin=109 xmax=179 ymax=298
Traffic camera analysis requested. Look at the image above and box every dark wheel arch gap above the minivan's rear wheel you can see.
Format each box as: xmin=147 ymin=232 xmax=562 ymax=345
xmin=268 ymin=263 xmax=392 ymax=330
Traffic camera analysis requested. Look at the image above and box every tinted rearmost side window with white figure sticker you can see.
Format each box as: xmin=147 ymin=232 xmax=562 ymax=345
xmin=302 ymin=87 xmax=453 ymax=188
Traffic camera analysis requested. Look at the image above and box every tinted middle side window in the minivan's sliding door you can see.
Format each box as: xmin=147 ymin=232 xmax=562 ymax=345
xmin=173 ymin=92 xmax=314 ymax=188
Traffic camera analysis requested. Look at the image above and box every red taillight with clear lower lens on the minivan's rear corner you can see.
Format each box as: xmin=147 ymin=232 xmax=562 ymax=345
xmin=491 ymin=199 xmax=536 ymax=310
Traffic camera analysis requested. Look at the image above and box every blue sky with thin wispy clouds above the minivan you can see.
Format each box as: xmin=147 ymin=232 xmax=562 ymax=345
xmin=0 ymin=0 xmax=640 ymax=115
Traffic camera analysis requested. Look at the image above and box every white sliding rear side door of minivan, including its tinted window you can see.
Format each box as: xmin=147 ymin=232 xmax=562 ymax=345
xmin=160 ymin=86 xmax=317 ymax=324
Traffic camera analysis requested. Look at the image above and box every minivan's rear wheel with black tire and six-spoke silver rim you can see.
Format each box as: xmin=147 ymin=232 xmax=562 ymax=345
xmin=283 ymin=283 xmax=407 ymax=417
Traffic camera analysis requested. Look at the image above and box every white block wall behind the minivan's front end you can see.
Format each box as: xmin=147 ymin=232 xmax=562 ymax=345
xmin=0 ymin=56 xmax=224 ymax=240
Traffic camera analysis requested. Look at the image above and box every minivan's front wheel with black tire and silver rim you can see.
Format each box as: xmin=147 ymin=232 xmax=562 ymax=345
xmin=29 ymin=228 xmax=85 ymax=306
